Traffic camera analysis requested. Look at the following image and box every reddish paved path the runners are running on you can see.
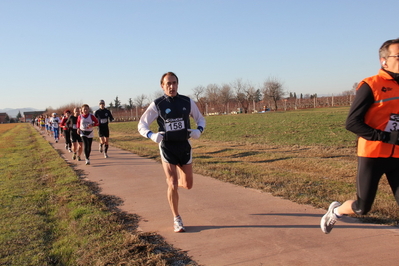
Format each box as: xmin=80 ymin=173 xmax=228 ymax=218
xmin=43 ymin=132 xmax=399 ymax=266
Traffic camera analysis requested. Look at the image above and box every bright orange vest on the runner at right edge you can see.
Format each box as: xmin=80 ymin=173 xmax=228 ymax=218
xmin=357 ymin=69 xmax=399 ymax=158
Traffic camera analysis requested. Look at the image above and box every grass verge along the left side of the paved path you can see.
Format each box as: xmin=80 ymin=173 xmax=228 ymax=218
xmin=0 ymin=124 xmax=196 ymax=265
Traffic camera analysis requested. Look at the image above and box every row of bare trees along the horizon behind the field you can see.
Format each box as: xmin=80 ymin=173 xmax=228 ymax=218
xmin=107 ymin=77 xmax=357 ymax=120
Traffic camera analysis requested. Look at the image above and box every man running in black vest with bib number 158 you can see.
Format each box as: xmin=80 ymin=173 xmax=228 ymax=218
xmin=138 ymin=72 xmax=205 ymax=233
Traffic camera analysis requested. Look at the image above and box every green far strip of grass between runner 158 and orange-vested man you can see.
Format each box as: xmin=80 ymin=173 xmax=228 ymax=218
xmin=204 ymin=107 xmax=355 ymax=146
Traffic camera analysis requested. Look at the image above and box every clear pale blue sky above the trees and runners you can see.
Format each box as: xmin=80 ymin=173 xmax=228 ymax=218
xmin=0 ymin=0 xmax=399 ymax=110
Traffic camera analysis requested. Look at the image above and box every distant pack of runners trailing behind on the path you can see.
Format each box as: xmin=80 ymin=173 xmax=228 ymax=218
xmin=35 ymin=100 xmax=114 ymax=165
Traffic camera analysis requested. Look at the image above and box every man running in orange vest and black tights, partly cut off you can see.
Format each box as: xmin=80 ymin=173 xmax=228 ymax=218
xmin=320 ymin=38 xmax=399 ymax=234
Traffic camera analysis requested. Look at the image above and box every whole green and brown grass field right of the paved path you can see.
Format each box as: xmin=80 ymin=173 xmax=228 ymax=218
xmin=111 ymin=107 xmax=399 ymax=225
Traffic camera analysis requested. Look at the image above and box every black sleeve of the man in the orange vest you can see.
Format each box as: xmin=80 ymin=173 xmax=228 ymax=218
xmin=346 ymin=83 xmax=385 ymax=140
